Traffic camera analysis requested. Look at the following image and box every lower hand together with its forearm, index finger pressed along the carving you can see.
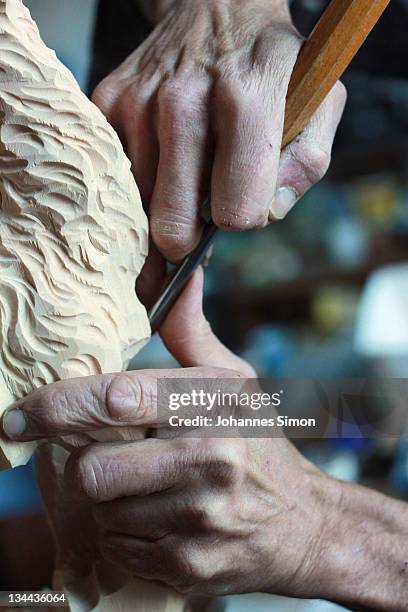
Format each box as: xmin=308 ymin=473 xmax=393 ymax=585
xmin=3 ymin=280 xmax=408 ymax=611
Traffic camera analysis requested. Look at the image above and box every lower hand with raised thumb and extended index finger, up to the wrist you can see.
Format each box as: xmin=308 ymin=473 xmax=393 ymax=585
xmin=3 ymin=271 xmax=334 ymax=594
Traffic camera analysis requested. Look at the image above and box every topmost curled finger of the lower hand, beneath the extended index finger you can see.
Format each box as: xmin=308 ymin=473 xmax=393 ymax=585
xmin=65 ymin=438 xmax=197 ymax=503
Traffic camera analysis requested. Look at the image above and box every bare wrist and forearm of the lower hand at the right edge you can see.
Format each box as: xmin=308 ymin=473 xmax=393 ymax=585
xmin=318 ymin=483 xmax=408 ymax=612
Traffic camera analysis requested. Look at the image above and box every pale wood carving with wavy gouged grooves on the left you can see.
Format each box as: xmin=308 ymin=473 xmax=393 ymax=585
xmin=0 ymin=0 xmax=150 ymax=466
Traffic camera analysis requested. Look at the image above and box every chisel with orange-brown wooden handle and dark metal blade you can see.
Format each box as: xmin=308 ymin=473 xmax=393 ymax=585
xmin=149 ymin=0 xmax=390 ymax=332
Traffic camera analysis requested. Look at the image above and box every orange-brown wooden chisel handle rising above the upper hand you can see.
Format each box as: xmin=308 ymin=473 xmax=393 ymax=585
xmin=282 ymin=0 xmax=390 ymax=148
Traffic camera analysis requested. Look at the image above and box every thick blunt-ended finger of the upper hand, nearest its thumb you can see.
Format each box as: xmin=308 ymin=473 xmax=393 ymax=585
xmin=211 ymin=81 xmax=283 ymax=230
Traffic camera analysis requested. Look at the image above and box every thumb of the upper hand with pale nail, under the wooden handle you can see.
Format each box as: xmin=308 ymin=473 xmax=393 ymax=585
xmin=269 ymin=82 xmax=346 ymax=221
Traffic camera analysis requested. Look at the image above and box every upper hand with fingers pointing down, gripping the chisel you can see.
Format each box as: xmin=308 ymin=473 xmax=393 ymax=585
xmin=93 ymin=0 xmax=346 ymax=260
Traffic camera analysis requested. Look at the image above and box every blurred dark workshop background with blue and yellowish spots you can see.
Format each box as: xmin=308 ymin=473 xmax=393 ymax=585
xmin=0 ymin=0 xmax=408 ymax=609
